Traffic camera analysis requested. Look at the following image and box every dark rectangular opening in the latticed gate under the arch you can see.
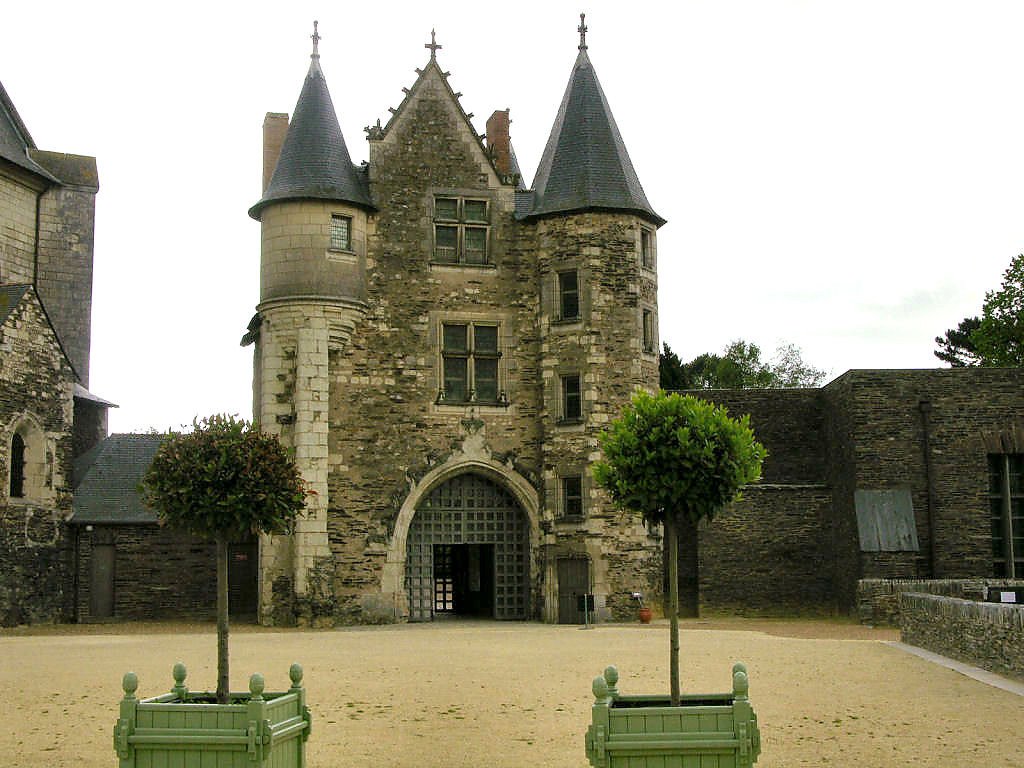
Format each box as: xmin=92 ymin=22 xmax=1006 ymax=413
xmin=433 ymin=544 xmax=495 ymax=618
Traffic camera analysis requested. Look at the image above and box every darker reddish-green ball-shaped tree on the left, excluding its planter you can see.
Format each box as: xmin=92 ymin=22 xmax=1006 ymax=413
xmin=140 ymin=415 xmax=311 ymax=703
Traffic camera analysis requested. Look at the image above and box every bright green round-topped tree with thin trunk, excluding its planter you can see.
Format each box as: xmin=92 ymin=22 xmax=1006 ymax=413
xmin=594 ymin=391 xmax=767 ymax=706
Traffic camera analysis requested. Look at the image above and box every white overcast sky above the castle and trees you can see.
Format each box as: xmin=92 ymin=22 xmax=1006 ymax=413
xmin=0 ymin=0 xmax=1024 ymax=432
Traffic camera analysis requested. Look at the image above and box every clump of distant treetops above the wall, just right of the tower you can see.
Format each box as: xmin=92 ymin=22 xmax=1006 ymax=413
xmin=658 ymin=339 xmax=825 ymax=390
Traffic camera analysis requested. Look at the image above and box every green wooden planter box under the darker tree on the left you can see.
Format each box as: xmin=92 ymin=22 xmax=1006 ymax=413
xmin=114 ymin=664 xmax=310 ymax=768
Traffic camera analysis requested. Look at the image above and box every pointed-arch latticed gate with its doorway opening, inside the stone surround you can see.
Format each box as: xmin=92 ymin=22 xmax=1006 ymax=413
xmin=406 ymin=472 xmax=530 ymax=622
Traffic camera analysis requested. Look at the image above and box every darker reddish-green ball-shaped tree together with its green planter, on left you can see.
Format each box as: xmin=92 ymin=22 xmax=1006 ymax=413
xmin=114 ymin=416 xmax=310 ymax=768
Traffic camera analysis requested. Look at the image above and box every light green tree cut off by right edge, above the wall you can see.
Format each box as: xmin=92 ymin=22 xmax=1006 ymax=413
xmin=971 ymin=254 xmax=1024 ymax=368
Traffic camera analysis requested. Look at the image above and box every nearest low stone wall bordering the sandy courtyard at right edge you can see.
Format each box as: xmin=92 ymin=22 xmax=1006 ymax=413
xmin=899 ymin=592 xmax=1024 ymax=679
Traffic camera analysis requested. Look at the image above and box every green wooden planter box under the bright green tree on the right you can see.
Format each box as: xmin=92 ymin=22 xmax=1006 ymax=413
xmin=586 ymin=664 xmax=761 ymax=768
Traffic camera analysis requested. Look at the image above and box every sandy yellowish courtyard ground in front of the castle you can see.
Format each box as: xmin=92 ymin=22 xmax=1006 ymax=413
xmin=0 ymin=620 xmax=1024 ymax=768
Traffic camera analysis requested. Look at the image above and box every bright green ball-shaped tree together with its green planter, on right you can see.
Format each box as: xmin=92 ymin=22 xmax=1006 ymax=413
xmin=587 ymin=392 xmax=767 ymax=768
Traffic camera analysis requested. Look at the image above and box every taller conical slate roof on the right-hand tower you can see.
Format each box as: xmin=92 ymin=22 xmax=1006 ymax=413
xmin=527 ymin=45 xmax=665 ymax=226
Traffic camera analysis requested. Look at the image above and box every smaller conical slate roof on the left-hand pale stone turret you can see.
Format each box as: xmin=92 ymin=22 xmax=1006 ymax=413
xmin=249 ymin=52 xmax=374 ymax=219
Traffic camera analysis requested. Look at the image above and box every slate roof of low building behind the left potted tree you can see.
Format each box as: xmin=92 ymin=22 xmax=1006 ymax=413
xmin=71 ymin=434 xmax=165 ymax=525
